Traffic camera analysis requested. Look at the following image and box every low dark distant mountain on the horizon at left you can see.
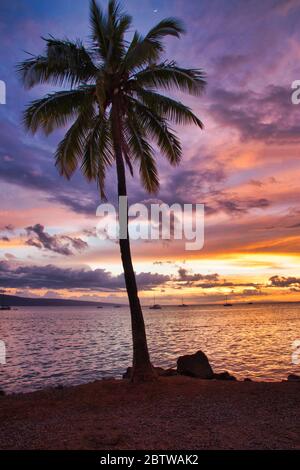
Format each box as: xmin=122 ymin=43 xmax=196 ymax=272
xmin=0 ymin=295 xmax=112 ymax=307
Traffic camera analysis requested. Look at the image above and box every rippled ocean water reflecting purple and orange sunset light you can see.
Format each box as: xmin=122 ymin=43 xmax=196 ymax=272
xmin=0 ymin=304 xmax=300 ymax=393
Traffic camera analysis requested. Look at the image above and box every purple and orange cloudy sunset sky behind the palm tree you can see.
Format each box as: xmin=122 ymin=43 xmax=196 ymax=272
xmin=0 ymin=0 xmax=300 ymax=303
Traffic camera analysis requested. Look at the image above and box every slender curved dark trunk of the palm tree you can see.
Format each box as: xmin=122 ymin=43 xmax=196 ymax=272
xmin=112 ymin=99 xmax=156 ymax=382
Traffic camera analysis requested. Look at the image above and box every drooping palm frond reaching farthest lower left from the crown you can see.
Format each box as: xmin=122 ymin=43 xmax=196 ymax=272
xmin=23 ymin=86 xmax=95 ymax=134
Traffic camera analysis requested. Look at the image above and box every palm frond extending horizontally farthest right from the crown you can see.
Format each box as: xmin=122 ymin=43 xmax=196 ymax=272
xmin=132 ymin=62 xmax=206 ymax=95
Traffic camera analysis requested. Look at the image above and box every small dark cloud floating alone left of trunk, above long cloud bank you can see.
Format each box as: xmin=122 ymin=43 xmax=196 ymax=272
xmin=26 ymin=224 xmax=88 ymax=256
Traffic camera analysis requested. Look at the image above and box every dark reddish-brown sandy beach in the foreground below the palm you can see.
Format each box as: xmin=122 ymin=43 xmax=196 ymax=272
xmin=0 ymin=376 xmax=300 ymax=450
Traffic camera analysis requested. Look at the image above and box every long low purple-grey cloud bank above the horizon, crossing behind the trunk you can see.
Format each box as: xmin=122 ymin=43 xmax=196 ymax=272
xmin=0 ymin=261 xmax=170 ymax=291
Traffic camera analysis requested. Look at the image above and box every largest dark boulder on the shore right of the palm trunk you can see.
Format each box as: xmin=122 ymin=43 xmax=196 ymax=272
xmin=177 ymin=351 xmax=214 ymax=379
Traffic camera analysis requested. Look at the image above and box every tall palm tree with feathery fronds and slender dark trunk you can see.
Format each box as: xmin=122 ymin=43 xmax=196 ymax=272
xmin=18 ymin=0 xmax=205 ymax=381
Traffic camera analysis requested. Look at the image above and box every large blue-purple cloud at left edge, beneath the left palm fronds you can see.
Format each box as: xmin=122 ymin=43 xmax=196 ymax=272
xmin=0 ymin=119 xmax=106 ymax=215
